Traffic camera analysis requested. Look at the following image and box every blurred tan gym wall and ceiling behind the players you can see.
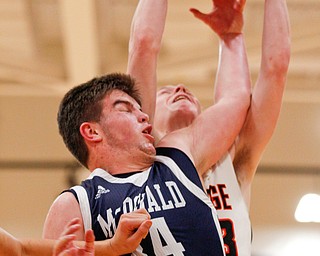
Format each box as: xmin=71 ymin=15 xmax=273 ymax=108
xmin=0 ymin=0 xmax=320 ymax=256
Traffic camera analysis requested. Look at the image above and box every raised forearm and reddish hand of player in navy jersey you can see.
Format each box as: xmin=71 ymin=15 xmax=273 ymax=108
xmin=190 ymin=0 xmax=251 ymax=116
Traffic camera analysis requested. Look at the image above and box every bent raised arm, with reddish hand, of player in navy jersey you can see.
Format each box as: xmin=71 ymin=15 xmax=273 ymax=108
xmin=162 ymin=0 xmax=251 ymax=172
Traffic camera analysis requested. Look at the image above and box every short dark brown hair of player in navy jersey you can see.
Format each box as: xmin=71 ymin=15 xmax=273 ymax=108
xmin=57 ymin=73 xmax=141 ymax=167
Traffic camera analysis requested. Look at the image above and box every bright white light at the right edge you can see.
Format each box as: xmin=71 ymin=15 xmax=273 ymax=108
xmin=294 ymin=194 xmax=320 ymax=222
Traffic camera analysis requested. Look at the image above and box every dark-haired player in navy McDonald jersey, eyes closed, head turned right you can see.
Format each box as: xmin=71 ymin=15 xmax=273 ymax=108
xmin=44 ymin=64 xmax=250 ymax=256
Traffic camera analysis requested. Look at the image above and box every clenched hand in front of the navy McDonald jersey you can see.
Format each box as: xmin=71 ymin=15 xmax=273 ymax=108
xmin=109 ymin=209 xmax=152 ymax=255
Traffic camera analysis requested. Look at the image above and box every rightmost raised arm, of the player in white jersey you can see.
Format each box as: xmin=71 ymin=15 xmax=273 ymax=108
xmin=234 ymin=0 xmax=290 ymax=190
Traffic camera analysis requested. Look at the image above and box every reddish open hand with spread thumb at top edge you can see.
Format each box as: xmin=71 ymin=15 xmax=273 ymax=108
xmin=190 ymin=0 xmax=246 ymax=37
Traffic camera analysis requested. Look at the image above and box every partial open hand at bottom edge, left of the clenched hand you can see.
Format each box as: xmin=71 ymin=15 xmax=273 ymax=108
xmin=53 ymin=218 xmax=95 ymax=256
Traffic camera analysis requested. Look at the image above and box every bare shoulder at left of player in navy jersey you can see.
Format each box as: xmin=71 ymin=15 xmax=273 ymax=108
xmin=43 ymin=192 xmax=84 ymax=240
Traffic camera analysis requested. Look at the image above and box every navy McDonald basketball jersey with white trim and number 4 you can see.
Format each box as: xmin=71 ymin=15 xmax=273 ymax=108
xmin=71 ymin=148 xmax=224 ymax=256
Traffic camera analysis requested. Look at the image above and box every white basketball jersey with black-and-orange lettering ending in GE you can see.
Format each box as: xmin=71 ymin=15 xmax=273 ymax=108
xmin=204 ymin=154 xmax=251 ymax=256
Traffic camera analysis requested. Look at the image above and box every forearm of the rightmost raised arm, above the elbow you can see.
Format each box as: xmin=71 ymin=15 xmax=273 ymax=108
xmin=261 ymin=0 xmax=290 ymax=76
